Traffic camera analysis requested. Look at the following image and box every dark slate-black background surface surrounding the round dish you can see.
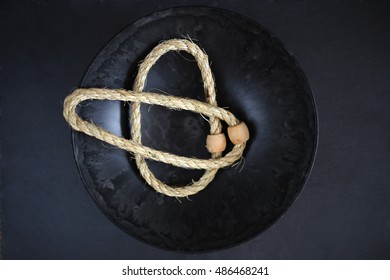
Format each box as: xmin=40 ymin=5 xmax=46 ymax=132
xmin=0 ymin=0 xmax=390 ymax=259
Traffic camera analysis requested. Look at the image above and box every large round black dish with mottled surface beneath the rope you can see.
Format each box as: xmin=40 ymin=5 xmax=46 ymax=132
xmin=73 ymin=7 xmax=317 ymax=252
